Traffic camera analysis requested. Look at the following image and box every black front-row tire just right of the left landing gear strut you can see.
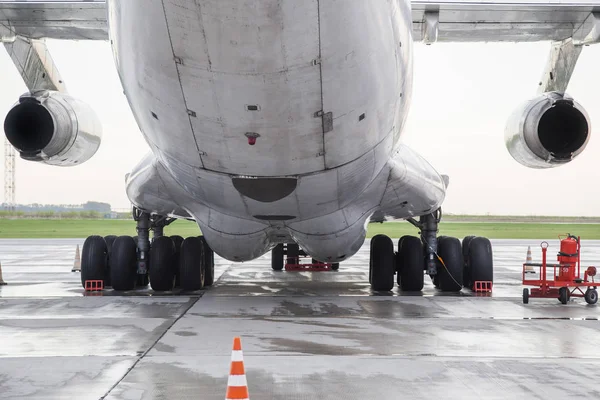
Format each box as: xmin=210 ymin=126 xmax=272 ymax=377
xmin=148 ymin=236 xmax=175 ymax=292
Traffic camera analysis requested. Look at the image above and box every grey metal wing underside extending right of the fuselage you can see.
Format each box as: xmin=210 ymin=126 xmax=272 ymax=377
xmin=412 ymin=0 xmax=600 ymax=44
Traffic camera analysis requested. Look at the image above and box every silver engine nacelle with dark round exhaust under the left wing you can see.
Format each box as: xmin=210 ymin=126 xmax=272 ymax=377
xmin=4 ymin=90 xmax=102 ymax=166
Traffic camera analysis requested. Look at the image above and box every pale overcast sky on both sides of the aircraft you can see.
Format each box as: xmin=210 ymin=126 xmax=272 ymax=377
xmin=0 ymin=41 xmax=600 ymax=216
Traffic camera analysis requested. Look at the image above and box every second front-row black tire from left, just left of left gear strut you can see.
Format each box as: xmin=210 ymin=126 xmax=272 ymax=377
xmin=110 ymin=236 xmax=137 ymax=291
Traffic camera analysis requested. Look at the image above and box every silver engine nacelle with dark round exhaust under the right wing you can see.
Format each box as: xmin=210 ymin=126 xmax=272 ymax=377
xmin=505 ymin=92 xmax=591 ymax=168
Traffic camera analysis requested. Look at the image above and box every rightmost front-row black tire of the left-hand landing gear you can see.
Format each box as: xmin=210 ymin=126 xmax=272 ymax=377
xmin=179 ymin=237 xmax=204 ymax=291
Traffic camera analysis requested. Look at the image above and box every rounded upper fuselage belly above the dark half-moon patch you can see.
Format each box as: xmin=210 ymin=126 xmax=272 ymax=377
xmin=109 ymin=0 xmax=411 ymax=176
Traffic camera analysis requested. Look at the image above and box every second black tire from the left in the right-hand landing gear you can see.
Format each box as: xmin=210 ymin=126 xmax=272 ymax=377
xmin=397 ymin=236 xmax=425 ymax=292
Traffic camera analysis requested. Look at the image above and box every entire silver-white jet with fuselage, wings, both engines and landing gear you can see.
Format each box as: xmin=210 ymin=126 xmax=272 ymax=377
xmin=0 ymin=0 xmax=600 ymax=291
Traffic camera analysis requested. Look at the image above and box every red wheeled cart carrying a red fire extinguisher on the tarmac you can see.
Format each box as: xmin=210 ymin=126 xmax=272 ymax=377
xmin=523 ymin=234 xmax=598 ymax=304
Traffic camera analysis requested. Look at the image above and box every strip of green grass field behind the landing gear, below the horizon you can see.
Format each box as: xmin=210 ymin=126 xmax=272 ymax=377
xmin=0 ymin=219 xmax=600 ymax=239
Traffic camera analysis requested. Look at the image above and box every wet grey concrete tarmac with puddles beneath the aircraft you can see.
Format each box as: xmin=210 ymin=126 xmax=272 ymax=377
xmin=0 ymin=239 xmax=600 ymax=400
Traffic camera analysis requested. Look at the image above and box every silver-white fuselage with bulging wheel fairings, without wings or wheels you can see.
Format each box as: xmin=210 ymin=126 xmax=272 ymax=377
xmin=109 ymin=0 xmax=445 ymax=261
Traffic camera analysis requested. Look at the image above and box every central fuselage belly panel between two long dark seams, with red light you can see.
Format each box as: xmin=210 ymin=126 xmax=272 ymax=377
xmin=165 ymin=0 xmax=324 ymax=176
